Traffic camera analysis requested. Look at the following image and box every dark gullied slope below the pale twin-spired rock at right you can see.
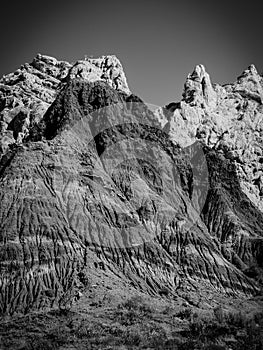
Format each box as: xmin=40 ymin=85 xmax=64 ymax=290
xmin=202 ymin=148 xmax=263 ymax=280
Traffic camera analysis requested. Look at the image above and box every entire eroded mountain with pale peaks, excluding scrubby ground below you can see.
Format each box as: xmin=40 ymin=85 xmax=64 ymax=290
xmin=0 ymin=55 xmax=263 ymax=313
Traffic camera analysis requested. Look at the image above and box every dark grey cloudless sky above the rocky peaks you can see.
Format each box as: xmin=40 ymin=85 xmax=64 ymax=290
xmin=0 ymin=0 xmax=263 ymax=105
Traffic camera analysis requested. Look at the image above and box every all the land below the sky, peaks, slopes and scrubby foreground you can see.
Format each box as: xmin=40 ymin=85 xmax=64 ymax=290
xmin=0 ymin=54 xmax=263 ymax=350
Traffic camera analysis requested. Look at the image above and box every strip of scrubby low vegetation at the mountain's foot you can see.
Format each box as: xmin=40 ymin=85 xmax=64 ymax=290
xmin=0 ymin=296 xmax=263 ymax=350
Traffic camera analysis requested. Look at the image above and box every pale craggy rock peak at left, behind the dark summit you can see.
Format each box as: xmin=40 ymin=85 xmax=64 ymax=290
xmin=0 ymin=54 xmax=131 ymax=158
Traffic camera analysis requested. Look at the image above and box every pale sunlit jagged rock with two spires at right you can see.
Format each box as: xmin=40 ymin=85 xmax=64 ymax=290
xmin=155 ymin=65 xmax=263 ymax=211
